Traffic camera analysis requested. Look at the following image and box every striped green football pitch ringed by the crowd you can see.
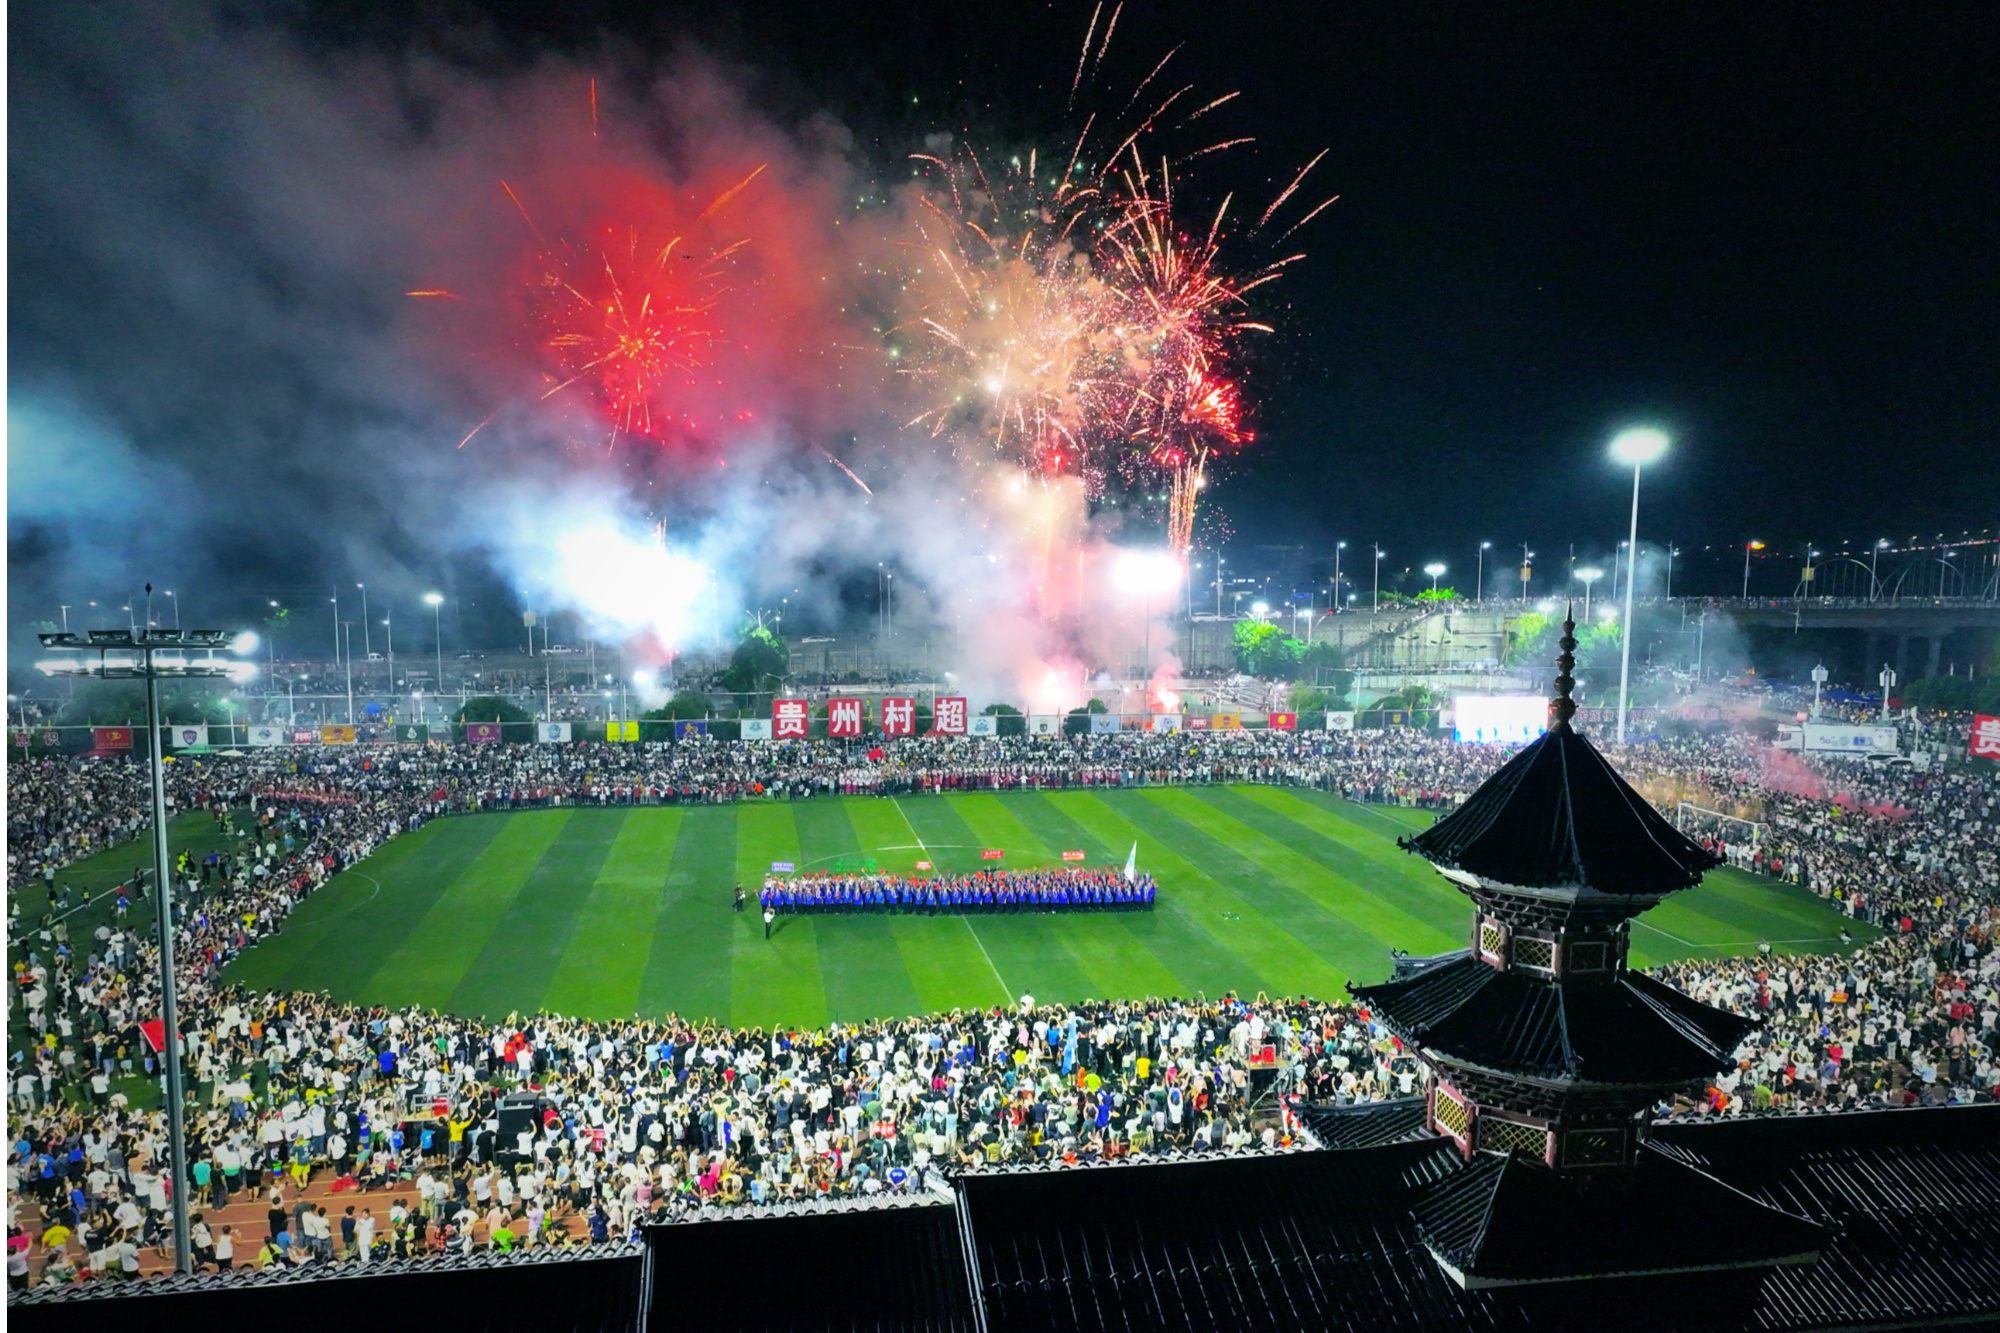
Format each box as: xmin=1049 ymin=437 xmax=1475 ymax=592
xmin=30 ymin=787 xmax=1874 ymax=1025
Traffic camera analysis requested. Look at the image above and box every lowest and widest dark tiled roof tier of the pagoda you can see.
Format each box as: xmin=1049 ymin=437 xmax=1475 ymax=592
xmin=1412 ymin=1145 xmax=1832 ymax=1287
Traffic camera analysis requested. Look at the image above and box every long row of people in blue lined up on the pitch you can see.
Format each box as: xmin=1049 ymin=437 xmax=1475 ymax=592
xmin=758 ymin=871 xmax=1160 ymax=915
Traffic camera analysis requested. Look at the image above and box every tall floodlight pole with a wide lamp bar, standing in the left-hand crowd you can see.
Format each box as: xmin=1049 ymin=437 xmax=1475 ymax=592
xmin=38 ymin=582 xmax=256 ymax=1273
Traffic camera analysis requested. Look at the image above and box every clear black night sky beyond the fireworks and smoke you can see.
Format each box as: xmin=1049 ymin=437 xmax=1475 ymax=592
xmin=10 ymin=0 xmax=2000 ymax=636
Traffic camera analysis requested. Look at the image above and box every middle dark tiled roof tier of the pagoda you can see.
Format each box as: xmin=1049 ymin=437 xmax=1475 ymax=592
xmin=1348 ymin=951 xmax=1756 ymax=1085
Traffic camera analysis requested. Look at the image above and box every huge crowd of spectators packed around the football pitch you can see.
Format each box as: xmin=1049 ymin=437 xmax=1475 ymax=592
xmin=8 ymin=716 xmax=2000 ymax=1281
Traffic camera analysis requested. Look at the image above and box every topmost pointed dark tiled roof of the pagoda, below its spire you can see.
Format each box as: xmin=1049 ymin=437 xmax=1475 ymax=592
xmin=1398 ymin=716 xmax=1722 ymax=899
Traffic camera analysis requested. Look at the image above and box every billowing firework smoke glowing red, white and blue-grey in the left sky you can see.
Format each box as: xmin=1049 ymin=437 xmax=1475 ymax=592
xmin=8 ymin=4 xmax=1174 ymax=707
